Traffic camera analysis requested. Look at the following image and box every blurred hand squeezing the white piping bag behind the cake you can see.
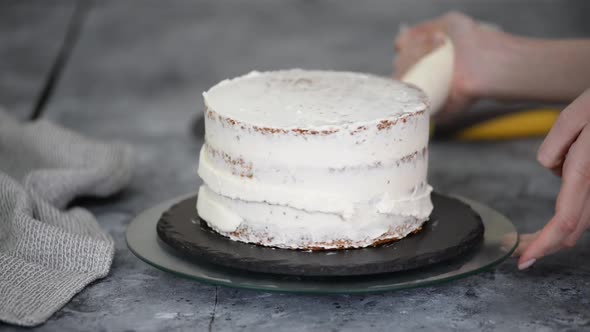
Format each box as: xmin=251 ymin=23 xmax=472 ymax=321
xmin=393 ymin=13 xmax=499 ymax=119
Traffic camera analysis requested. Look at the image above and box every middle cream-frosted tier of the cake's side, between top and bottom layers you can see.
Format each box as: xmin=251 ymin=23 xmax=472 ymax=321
xmin=199 ymin=144 xmax=432 ymax=219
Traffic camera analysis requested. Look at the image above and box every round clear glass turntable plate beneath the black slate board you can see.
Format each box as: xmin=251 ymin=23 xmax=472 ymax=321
xmin=126 ymin=194 xmax=518 ymax=294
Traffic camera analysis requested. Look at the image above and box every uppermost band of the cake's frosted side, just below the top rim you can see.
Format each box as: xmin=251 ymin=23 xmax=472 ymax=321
xmin=205 ymin=109 xmax=429 ymax=168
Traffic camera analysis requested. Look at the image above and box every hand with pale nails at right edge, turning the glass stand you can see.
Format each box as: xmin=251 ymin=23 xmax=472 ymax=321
xmin=516 ymin=89 xmax=590 ymax=270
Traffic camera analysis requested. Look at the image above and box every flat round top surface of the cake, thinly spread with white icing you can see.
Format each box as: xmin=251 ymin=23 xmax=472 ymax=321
xmin=203 ymin=69 xmax=428 ymax=129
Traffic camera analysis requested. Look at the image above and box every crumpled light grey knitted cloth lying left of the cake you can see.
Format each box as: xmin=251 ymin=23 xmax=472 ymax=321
xmin=0 ymin=109 xmax=133 ymax=326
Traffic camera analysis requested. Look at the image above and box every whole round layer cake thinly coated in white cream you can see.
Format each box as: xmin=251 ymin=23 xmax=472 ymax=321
xmin=197 ymin=69 xmax=432 ymax=250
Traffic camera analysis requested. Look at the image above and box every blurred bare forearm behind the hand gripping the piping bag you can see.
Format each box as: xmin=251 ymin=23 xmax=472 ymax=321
xmin=479 ymin=32 xmax=590 ymax=102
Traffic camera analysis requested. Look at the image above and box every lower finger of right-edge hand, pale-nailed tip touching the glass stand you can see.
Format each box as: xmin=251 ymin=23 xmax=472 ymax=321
xmin=519 ymin=127 xmax=590 ymax=269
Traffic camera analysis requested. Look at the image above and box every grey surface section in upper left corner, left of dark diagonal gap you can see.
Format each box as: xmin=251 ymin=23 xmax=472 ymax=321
xmin=0 ymin=0 xmax=75 ymax=119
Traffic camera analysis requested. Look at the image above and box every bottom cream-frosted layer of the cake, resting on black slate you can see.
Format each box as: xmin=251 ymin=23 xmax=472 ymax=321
xmin=197 ymin=186 xmax=426 ymax=249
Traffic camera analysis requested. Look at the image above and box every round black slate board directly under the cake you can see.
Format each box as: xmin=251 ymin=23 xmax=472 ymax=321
xmin=157 ymin=193 xmax=484 ymax=277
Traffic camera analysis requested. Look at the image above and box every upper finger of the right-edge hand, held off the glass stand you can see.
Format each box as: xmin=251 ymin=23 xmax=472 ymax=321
xmin=537 ymin=90 xmax=590 ymax=169
